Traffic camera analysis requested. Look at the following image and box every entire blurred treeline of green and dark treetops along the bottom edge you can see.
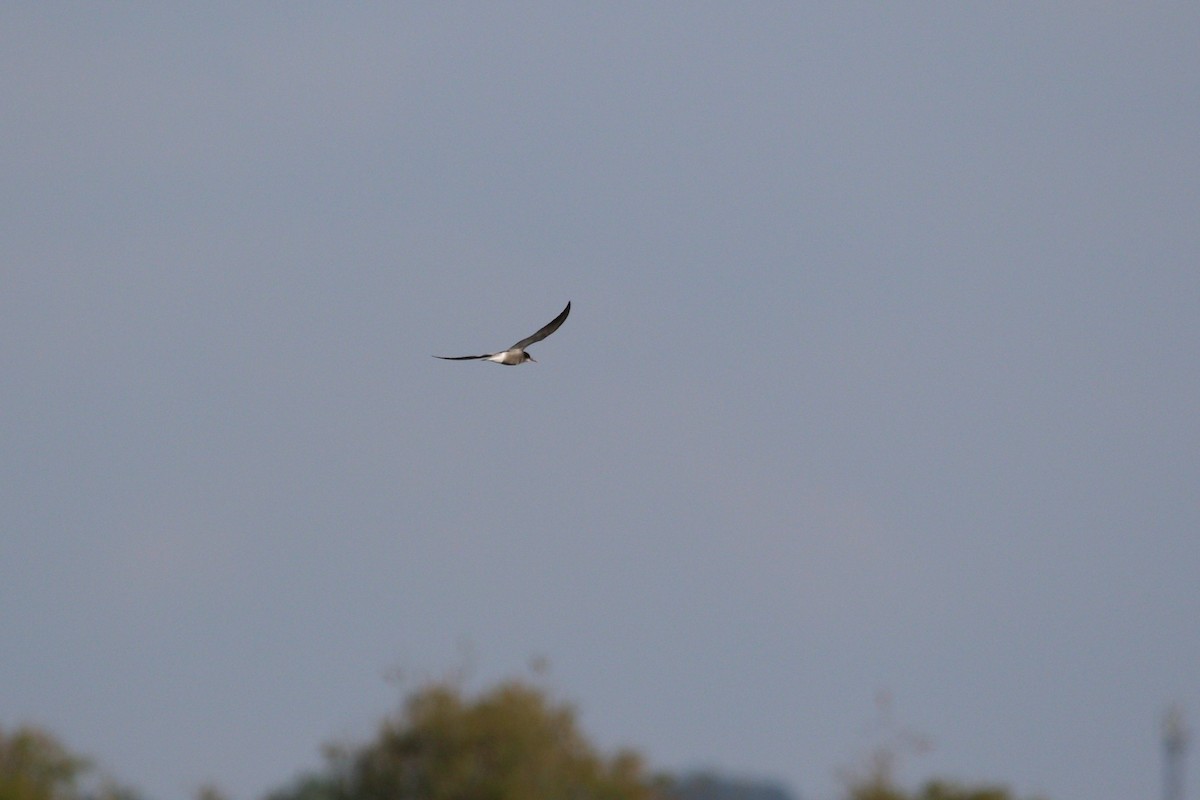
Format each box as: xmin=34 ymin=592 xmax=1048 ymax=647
xmin=0 ymin=680 xmax=1041 ymax=800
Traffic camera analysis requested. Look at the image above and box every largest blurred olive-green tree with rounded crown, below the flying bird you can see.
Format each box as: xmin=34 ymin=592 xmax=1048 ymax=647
xmin=271 ymin=681 xmax=658 ymax=800
